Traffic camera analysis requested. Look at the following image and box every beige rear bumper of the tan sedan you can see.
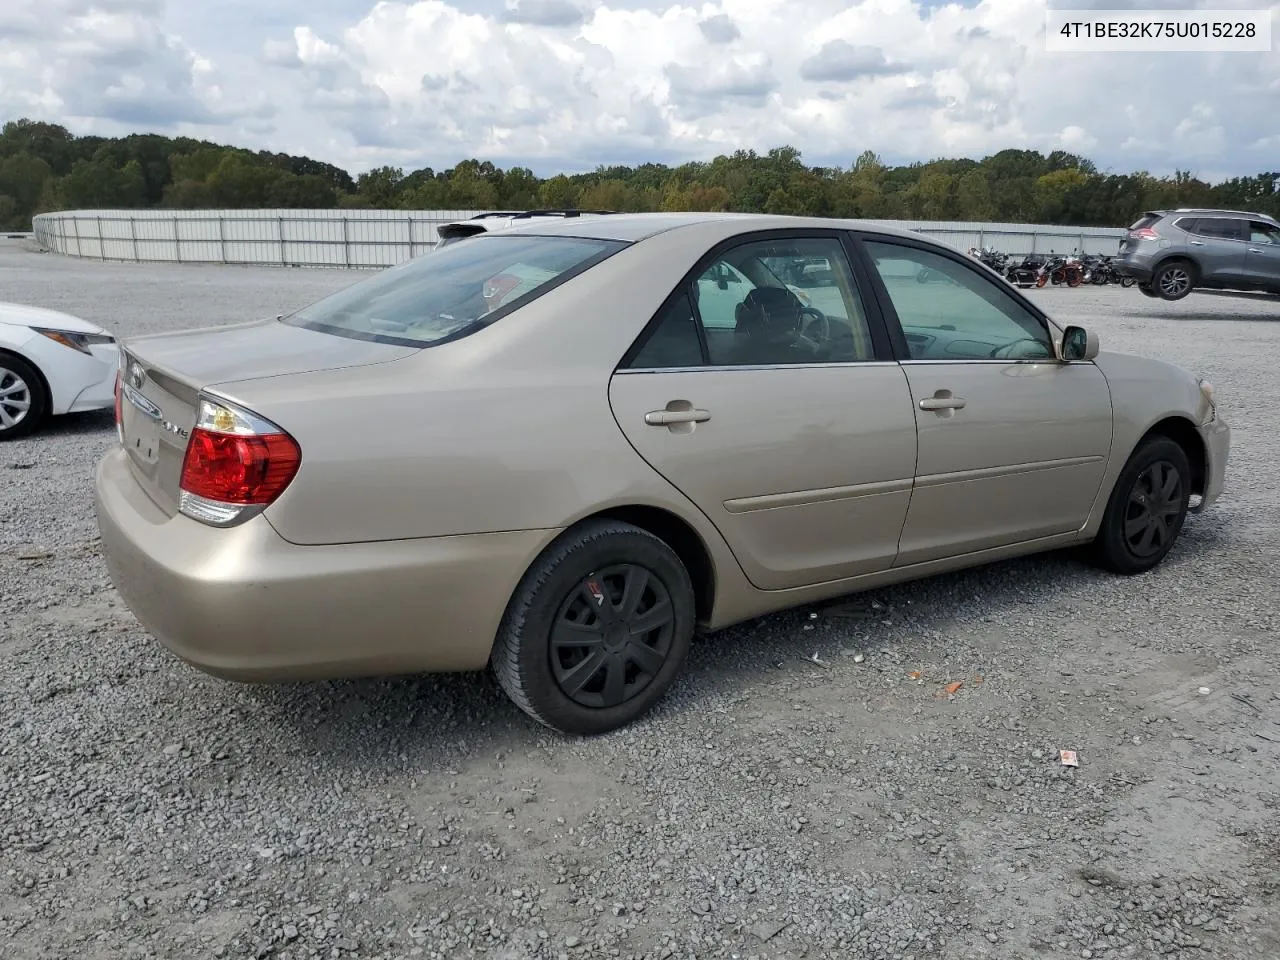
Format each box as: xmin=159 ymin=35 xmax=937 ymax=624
xmin=95 ymin=448 xmax=556 ymax=681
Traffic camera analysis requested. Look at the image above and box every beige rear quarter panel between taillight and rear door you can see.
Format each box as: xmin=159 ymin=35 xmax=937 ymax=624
xmin=209 ymin=224 xmax=740 ymax=572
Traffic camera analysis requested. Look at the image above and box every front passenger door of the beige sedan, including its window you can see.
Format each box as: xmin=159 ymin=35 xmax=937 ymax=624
xmin=863 ymin=239 xmax=1111 ymax=566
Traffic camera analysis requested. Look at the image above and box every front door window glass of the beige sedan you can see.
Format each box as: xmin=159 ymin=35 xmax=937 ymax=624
xmin=865 ymin=242 xmax=1053 ymax=360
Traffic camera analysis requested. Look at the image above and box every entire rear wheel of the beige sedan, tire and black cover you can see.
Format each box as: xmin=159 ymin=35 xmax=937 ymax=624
xmin=490 ymin=521 xmax=696 ymax=736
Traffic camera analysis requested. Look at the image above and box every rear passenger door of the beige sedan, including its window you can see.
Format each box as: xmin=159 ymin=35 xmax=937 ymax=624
xmin=609 ymin=232 xmax=915 ymax=590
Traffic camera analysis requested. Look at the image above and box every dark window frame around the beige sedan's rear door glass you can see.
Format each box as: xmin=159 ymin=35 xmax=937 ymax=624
xmin=613 ymin=227 xmax=897 ymax=374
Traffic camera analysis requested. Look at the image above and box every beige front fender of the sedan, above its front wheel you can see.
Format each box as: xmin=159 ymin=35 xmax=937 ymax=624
xmin=1082 ymin=352 xmax=1208 ymax=536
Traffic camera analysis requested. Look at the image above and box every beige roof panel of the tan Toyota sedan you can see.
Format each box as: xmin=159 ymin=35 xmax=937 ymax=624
xmin=495 ymin=212 xmax=927 ymax=243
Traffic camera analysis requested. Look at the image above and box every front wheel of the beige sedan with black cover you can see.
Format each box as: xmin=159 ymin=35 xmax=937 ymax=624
xmin=1093 ymin=436 xmax=1192 ymax=576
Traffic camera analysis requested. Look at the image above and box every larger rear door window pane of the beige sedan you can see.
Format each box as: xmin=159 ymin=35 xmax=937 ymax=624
xmin=692 ymin=237 xmax=876 ymax=366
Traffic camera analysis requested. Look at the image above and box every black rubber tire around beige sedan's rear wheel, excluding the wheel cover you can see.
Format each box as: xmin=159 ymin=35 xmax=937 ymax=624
xmin=495 ymin=525 xmax=696 ymax=735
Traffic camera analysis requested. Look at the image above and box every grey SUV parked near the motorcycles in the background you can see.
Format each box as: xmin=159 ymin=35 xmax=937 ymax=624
xmin=1115 ymin=210 xmax=1280 ymax=300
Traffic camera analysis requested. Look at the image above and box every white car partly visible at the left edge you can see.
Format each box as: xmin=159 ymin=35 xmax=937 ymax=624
xmin=0 ymin=302 xmax=120 ymax=440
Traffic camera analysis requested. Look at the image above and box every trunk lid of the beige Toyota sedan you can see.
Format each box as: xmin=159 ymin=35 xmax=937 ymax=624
xmin=119 ymin=320 xmax=417 ymax=516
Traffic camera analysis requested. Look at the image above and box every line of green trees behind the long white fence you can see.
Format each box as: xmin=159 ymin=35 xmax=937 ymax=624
xmin=0 ymin=119 xmax=1280 ymax=230
